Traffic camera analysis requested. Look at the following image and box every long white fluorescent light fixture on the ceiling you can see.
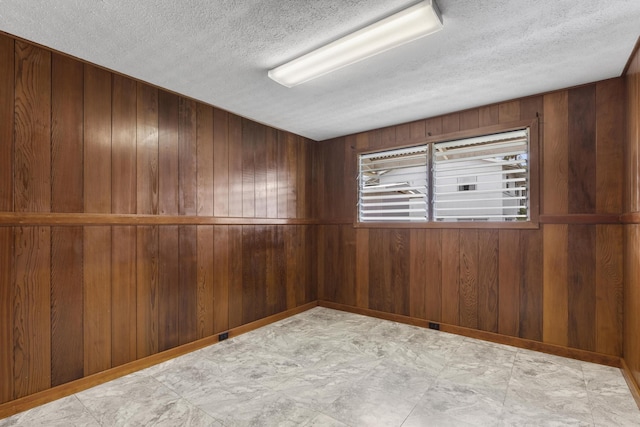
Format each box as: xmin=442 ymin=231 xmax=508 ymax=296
xmin=269 ymin=0 xmax=442 ymax=87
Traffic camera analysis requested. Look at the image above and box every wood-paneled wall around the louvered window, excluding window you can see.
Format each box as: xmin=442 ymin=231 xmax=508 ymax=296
xmin=312 ymin=78 xmax=624 ymax=356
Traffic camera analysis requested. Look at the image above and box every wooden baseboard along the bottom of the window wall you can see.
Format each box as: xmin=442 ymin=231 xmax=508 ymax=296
xmin=318 ymin=301 xmax=622 ymax=368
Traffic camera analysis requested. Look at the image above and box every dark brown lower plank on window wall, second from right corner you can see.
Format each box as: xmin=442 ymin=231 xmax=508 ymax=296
xmin=567 ymin=224 xmax=596 ymax=351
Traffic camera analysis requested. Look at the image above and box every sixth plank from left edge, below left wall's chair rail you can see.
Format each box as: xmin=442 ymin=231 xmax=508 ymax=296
xmin=136 ymin=226 xmax=158 ymax=358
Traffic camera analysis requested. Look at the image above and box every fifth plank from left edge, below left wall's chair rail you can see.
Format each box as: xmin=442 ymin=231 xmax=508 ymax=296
xmin=110 ymin=226 xmax=137 ymax=366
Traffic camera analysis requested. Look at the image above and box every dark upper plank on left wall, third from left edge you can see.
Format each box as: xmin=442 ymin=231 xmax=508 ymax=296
xmin=51 ymin=54 xmax=84 ymax=212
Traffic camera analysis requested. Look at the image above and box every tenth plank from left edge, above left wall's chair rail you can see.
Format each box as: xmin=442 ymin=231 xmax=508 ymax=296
xmin=213 ymin=108 xmax=229 ymax=216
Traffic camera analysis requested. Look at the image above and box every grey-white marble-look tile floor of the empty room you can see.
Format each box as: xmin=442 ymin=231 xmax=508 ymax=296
xmin=0 ymin=307 xmax=640 ymax=427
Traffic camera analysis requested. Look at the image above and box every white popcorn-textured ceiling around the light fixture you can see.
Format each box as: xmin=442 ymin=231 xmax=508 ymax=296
xmin=0 ymin=0 xmax=640 ymax=140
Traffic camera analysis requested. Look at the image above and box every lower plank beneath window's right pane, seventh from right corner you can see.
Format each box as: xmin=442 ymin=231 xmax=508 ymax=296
xmin=458 ymin=230 xmax=478 ymax=329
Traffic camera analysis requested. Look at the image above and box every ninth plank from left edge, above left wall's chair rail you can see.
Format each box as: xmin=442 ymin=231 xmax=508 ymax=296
xmin=196 ymin=104 xmax=214 ymax=216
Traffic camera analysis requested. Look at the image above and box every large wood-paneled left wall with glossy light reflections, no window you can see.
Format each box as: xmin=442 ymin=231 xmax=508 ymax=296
xmin=0 ymin=35 xmax=317 ymax=403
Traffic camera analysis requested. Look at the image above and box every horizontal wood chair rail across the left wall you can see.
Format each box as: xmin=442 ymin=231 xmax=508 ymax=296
xmin=0 ymin=212 xmax=321 ymax=226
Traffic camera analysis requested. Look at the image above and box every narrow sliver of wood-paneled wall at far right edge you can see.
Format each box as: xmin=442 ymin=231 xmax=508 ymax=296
xmin=623 ymin=41 xmax=640 ymax=396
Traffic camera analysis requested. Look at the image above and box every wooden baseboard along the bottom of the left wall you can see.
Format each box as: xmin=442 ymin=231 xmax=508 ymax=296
xmin=0 ymin=301 xmax=318 ymax=420
